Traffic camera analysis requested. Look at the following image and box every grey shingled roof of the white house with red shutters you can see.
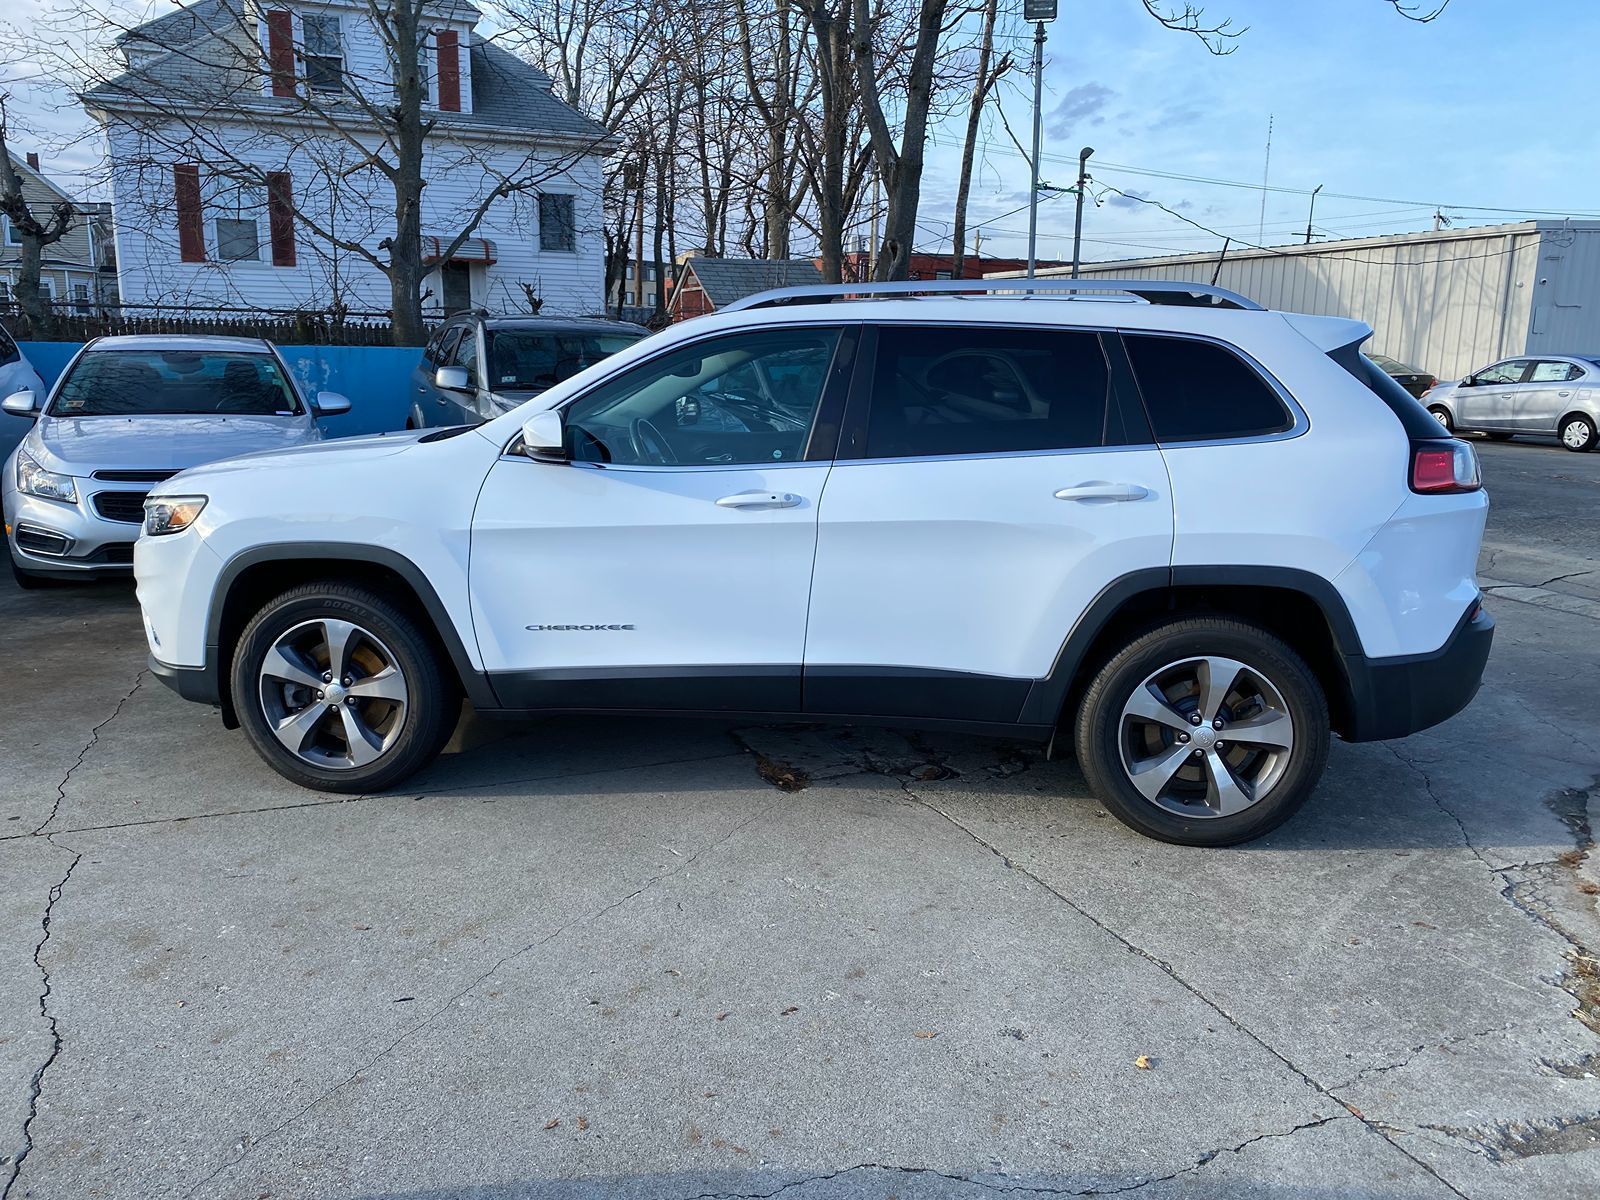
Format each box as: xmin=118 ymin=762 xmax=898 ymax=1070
xmin=85 ymin=0 xmax=610 ymax=141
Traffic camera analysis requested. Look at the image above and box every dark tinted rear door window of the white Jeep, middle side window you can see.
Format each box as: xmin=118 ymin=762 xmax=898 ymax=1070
xmin=866 ymin=325 xmax=1110 ymax=458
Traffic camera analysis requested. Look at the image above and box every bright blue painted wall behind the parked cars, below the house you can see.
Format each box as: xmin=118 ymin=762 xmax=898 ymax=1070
xmin=14 ymin=342 xmax=422 ymax=438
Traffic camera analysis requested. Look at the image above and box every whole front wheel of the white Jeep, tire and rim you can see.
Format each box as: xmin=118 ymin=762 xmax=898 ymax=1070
xmin=232 ymin=582 xmax=461 ymax=792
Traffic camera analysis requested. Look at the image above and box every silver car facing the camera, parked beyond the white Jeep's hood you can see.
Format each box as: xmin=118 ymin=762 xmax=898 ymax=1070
xmin=0 ymin=336 xmax=350 ymax=587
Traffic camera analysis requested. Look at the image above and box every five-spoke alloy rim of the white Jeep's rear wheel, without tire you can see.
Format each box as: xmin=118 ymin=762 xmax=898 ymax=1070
xmin=1117 ymin=654 xmax=1294 ymax=819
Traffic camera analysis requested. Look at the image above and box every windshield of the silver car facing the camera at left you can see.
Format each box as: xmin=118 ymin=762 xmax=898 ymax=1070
xmin=50 ymin=350 xmax=302 ymax=416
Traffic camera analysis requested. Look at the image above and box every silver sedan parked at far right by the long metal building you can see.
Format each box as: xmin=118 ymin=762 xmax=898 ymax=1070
xmin=1422 ymin=355 xmax=1600 ymax=451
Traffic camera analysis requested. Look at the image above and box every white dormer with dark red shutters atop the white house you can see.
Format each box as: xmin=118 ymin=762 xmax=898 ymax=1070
xmin=256 ymin=0 xmax=478 ymax=112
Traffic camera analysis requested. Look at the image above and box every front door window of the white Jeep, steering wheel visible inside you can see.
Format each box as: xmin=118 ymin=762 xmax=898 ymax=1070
xmin=565 ymin=328 xmax=838 ymax=467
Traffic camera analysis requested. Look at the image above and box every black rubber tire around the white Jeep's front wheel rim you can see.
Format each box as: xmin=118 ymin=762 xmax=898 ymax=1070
xmin=230 ymin=581 xmax=461 ymax=792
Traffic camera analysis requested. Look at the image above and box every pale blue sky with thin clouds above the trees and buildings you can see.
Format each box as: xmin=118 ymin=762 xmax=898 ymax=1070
xmin=5 ymin=0 xmax=1600 ymax=261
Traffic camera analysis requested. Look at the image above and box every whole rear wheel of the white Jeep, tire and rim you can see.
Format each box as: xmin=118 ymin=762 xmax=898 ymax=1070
xmin=1077 ymin=619 xmax=1330 ymax=846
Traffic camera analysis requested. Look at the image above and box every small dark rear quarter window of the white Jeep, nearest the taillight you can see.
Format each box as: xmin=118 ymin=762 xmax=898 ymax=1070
xmin=1123 ymin=334 xmax=1294 ymax=442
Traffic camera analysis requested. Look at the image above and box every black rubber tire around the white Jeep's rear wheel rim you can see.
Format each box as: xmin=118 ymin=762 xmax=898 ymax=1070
xmin=1077 ymin=618 xmax=1330 ymax=846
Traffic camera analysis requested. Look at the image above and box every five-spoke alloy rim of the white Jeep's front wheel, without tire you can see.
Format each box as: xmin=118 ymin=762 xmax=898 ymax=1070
xmin=259 ymin=618 xmax=411 ymax=771
